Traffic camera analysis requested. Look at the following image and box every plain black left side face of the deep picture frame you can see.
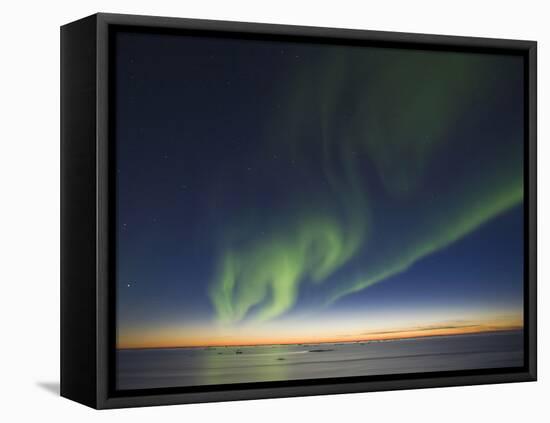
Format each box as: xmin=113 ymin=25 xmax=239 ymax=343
xmin=60 ymin=16 xmax=97 ymax=407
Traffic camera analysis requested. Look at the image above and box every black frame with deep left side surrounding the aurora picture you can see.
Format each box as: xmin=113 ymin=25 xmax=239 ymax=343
xmin=61 ymin=13 xmax=537 ymax=409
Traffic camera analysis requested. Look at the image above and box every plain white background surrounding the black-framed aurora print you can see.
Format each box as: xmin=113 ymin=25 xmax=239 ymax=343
xmin=0 ymin=0 xmax=550 ymax=423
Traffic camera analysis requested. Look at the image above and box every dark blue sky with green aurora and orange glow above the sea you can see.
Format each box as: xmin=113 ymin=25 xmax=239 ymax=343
xmin=115 ymin=29 xmax=524 ymax=347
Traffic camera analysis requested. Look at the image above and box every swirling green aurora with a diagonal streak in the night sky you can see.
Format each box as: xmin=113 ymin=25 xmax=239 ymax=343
xmin=210 ymin=47 xmax=523 ymax=324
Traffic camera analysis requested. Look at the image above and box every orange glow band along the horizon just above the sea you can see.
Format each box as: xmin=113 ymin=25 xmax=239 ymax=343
xmin=117 ymin=314 xmax=523 ymax=349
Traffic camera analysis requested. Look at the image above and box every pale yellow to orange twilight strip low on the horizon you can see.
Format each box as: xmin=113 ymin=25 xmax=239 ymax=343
xmin=117 ymin=312 xmax=523 ymax=349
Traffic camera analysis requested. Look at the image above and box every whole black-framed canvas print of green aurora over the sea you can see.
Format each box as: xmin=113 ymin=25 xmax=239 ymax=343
xmin=61 ymin=14 xmax=536 ymax=408
